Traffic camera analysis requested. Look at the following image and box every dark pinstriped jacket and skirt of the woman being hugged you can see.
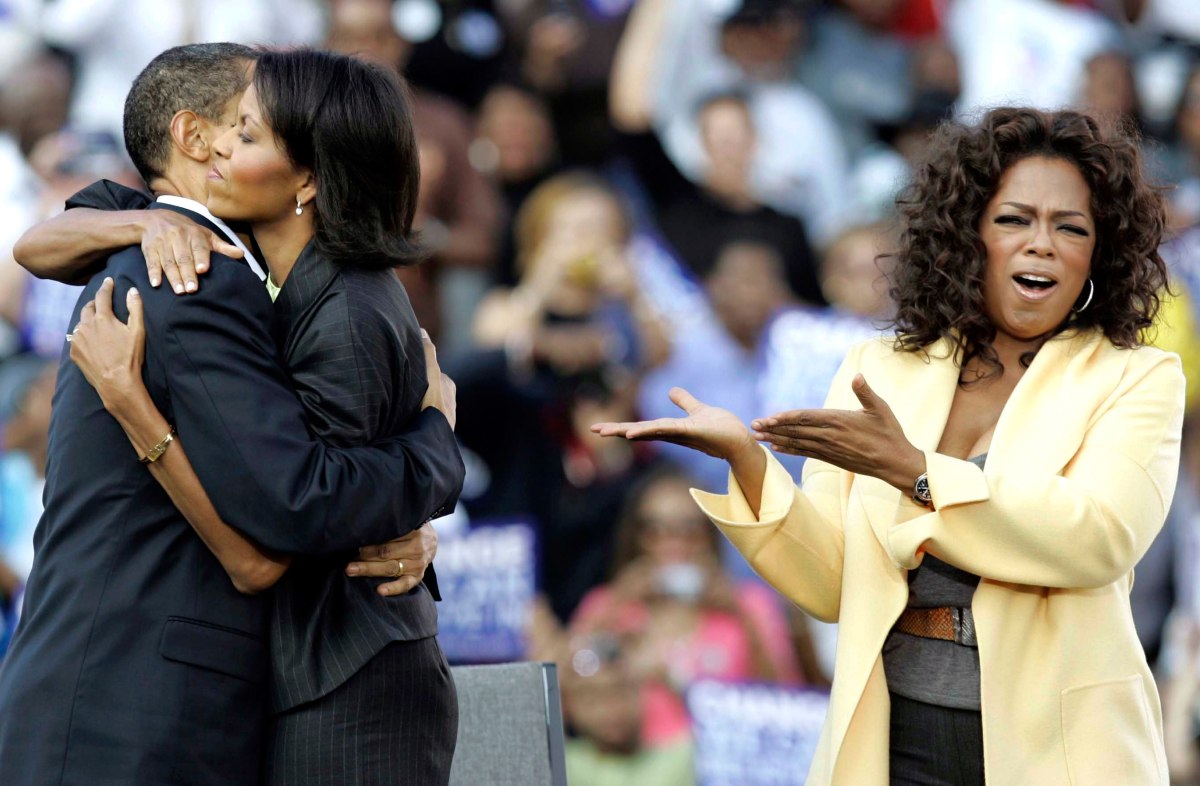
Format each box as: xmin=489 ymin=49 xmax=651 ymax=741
xmin=269 ymin=245 xmax=457 ymax=786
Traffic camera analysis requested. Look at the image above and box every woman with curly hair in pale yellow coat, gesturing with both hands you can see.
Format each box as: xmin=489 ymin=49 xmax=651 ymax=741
xmin=594 ymin=109 xmax=1184 ymax=786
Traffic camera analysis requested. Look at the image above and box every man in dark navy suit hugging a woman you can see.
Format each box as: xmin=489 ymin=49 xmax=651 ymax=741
xmin=0 ymin=44 xmax=463 ymax=786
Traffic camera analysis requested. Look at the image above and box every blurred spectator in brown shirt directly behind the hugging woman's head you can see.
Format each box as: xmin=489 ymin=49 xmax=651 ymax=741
xmin=325 ymin=0 xmax=500 ymax=356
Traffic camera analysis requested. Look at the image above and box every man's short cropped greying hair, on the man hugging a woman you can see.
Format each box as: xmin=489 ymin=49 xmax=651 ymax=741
xmin=125 ymin=43 xmax=258 ymax=185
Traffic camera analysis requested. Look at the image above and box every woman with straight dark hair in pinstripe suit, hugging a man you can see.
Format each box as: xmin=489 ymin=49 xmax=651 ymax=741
xmin=65 ymin=52 xmax=457 ymax=786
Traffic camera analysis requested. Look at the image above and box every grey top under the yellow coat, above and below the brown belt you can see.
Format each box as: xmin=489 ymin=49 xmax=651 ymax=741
xmin=883 ymin=454 xmax=988 ymax=710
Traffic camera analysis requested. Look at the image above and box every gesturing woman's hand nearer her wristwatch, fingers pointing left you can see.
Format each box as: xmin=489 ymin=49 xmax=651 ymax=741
xmin=751 ymin=374 xmax=925 ymax=490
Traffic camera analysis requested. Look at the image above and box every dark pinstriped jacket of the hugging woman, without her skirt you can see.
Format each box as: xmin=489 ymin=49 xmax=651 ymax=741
xmin=271 ymin=242 xmax=451 ymax=712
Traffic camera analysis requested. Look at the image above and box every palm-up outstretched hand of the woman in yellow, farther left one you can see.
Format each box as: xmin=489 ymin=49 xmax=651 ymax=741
xmin=592 ymin=388 xmax=754 ymax=460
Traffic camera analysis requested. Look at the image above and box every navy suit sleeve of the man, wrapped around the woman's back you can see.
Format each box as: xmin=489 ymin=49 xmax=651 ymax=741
xmin=162 ymin=265 xmax=463 ymax=554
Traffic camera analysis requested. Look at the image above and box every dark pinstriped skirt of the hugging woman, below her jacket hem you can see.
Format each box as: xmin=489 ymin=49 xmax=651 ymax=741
xmin=266 ymin=637 xmax=458 ymax=786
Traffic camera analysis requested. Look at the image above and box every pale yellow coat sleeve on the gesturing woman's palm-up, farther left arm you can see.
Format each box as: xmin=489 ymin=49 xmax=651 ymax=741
xmin=691 ymin=340 xmax=860 ymax=622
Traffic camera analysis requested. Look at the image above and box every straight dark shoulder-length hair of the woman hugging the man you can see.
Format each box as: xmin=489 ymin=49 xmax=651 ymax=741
xmin=254 ymin=49 xmax=425 ymax=268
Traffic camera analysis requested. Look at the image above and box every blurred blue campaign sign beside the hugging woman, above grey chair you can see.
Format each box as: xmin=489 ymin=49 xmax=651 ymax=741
xmin=434 ymin=520 xmax=538 ymax=664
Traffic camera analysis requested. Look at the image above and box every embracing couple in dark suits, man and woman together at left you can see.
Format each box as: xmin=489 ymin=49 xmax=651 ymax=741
xmin=0 ymin=44 xmax=463 ymax=786
